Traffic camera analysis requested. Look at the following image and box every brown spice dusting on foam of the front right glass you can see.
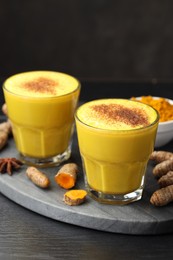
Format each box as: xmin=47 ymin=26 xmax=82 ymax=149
xmin=91 ymin=104 xmax=149 ymax=127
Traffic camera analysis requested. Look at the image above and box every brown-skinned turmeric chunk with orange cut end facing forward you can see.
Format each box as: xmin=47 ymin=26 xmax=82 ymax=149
xmin=55 ymin=163 xmax=78 ymax=189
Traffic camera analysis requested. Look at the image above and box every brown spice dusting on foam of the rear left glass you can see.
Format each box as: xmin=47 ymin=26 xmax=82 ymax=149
xmin=22 ymin=77 xmax=58 ymax=95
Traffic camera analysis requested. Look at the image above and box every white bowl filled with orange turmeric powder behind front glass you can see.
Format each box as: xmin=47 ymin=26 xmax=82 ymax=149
xmin=131 ymin=96 xmax=173 ymax=147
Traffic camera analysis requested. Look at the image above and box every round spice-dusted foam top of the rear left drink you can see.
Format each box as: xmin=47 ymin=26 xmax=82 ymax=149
xmin=5 ymin=71 xmax=79 ymax=97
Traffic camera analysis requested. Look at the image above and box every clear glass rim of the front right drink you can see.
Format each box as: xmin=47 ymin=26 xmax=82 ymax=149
xmin=74 ymin=98 xmax=160 ymax=133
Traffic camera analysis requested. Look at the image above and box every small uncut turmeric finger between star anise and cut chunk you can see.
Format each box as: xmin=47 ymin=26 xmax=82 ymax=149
xmin=26 ymin=166 xmax=50 ymax=188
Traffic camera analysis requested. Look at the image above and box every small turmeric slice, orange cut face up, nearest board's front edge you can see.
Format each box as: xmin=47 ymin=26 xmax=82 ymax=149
xmin=63 ymin=190 xmax=87 ymax=206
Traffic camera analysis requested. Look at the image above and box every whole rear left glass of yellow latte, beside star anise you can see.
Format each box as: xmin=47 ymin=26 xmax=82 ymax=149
xmin=3 ymin=71 xmax=80 ymax=167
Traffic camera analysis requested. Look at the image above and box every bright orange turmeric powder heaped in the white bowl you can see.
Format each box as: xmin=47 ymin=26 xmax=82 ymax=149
xmin=131 ymin=96 xmax=173 ymax=122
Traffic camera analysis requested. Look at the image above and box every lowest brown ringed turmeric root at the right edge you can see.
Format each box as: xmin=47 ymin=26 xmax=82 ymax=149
xmin=150 ymin=185 xmax=173 ymax=206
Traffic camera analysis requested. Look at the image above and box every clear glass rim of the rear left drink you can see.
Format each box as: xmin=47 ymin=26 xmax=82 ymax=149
xmin=2 ymin=70 xmax=81 ymax=100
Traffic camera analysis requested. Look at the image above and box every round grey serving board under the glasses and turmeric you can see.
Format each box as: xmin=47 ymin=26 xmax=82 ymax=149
xmin=0 ymin=134 xmax=173 ymax=235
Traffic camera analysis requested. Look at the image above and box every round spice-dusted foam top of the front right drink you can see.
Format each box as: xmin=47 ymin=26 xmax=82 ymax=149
xmin=77 ymin=99 xmax=157 ymax=130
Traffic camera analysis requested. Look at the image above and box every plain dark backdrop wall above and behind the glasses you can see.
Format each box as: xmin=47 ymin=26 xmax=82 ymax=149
xmin=0 ymin=0 xmax=173 ymax=81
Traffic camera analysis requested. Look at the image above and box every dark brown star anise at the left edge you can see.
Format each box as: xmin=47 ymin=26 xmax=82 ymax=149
xmin=0 ymin=158 xmax=23 ymax=175
